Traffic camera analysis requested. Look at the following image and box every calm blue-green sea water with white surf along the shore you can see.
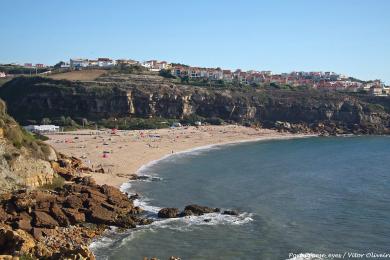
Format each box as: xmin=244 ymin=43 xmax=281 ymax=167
xmin=91 ymin=137 xmax=390 ymax=260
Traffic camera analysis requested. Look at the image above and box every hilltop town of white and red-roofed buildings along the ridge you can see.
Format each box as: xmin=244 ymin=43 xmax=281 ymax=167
xmin=0 ymin=58 xmax=390 ymax=96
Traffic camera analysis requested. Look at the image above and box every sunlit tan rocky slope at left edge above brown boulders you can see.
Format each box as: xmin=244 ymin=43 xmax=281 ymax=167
xmin=0 ymin=100 xmax=57 ymax=193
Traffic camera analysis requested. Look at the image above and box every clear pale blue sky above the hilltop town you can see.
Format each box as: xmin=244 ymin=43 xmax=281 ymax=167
xmin=0 ymin=0 xmax=390 ymax=84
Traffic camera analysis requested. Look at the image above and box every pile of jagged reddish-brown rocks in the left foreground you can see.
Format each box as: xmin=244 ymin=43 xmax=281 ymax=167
xmin=0 ymin=177 xmax=151 ymax=259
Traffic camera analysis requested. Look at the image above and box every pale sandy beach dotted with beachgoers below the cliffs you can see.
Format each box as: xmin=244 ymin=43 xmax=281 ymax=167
xmin=47 ymin=125 xmax=305 ymax=187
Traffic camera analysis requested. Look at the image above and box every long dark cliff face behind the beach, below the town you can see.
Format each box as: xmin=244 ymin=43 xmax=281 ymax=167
xmin=0 ymin=75 xmax=390 ymax=134
